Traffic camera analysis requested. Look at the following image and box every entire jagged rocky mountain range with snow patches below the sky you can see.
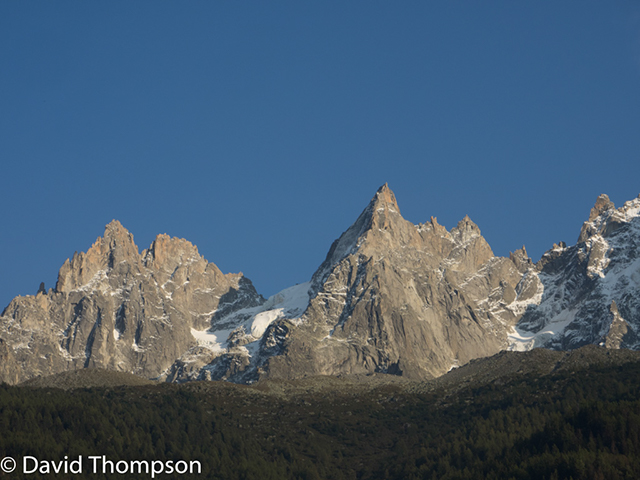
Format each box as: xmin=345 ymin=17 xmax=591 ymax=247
xmin=0 ymin=184 xmax=640 ymax=384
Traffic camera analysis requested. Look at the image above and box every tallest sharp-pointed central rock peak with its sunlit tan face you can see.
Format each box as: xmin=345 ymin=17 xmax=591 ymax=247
xmin=230 ymin=185 xmax=527 ymax=378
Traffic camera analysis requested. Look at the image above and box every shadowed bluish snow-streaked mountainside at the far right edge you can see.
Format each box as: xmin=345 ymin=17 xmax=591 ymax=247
xmin=510 ymin=195 xmax=640 ymax=350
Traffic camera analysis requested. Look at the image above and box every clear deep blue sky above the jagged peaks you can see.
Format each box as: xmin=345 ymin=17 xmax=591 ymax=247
xmin=0 ymin=0 xmax=640 ymax=309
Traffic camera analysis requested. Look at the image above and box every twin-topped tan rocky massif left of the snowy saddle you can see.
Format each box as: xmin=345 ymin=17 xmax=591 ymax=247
xmin=0 ymin=220 xmax=264 ymax=383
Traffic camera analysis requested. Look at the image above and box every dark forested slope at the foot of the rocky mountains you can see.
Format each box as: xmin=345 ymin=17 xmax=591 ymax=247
xmin=0 ymin=346 xmax=640 ymax=480
